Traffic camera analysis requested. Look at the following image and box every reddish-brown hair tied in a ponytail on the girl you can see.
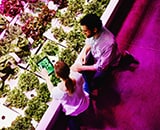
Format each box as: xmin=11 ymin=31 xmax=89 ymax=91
xmin=54 ymin=61 xmax=75 ymax=94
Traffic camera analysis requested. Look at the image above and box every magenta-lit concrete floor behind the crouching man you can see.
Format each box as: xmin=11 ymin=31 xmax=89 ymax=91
xmin=82 ymin=0 xmax=160 ymax=130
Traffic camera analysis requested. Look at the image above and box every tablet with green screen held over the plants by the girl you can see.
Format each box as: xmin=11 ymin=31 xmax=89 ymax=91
xmin=37 ymin=56 xmax=54 ymax=75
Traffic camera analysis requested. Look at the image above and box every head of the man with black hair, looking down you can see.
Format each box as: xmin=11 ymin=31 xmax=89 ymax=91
xmin=80 ymin=14 xmax=102 ymax=38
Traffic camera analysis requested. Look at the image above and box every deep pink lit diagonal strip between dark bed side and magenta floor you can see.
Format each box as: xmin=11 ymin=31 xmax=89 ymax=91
xmin=117 ymin=0 xmax=149 ymax=51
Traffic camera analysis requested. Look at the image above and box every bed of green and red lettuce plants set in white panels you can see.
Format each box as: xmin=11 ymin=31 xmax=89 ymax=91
xmin=0 ymin=0 xmax=108 ymax=130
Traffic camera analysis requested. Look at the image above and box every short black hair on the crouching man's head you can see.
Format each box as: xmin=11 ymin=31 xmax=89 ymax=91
xmin=80 ymin=14 xmax=102 ymax=31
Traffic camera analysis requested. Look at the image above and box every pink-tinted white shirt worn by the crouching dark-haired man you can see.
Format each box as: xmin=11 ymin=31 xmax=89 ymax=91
xmin=85 ymin=28 xmax=119 ymax=70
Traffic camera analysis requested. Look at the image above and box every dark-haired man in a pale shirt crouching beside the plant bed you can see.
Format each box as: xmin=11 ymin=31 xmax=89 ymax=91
xmin=71 ymin=14 xmax=120 ymax=93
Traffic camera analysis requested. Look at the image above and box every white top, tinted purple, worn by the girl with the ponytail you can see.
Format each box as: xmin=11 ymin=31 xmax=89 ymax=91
xmin=52 ymin=72 xmax=89 ymax=116
